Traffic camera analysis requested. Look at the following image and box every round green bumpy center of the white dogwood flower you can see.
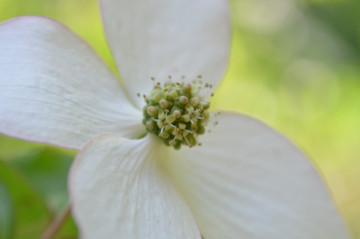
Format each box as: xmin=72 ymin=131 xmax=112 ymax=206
xmin=143 ymin=76 xmax=211 ymax=149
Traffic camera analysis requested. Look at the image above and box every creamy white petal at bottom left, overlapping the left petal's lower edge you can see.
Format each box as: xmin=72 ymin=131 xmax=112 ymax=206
xmin=69 ymin=135 xmax=201 ymax=239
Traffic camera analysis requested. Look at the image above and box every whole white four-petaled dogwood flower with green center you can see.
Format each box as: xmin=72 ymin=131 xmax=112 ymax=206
xmin=0 ymin=0 xmax=348 ymax=239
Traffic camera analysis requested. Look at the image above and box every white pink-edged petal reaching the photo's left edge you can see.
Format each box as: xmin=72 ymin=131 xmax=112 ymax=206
xmin=0 ymin=16 xmax=144 ymax=148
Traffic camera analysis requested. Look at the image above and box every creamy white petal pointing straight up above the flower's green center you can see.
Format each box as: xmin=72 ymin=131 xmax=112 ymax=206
xmin=100 ymin=0 xmax=230 ymax=105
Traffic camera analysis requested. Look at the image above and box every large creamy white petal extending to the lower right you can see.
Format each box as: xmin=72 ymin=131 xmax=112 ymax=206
xmin=164 ymin=113 xmax=349 ymax=239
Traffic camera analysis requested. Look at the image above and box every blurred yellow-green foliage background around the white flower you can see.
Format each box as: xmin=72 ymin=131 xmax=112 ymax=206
xmin=0 ymin=0 xmax=360 ymax=239
